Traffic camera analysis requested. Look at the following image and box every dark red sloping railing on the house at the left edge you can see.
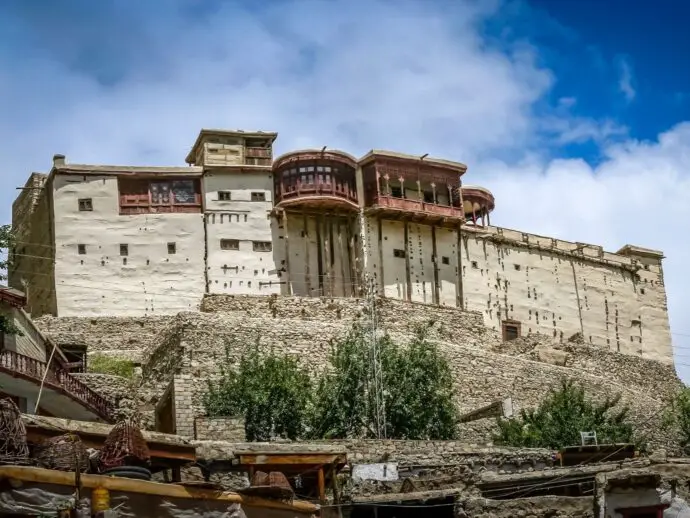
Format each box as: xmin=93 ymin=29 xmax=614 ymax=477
xmin=0 ymin=351 xmax=113 ymax=421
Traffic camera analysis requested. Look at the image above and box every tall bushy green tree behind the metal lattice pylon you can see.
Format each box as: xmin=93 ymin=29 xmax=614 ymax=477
xmin=311 ymin=324 xmax=458 ymax=439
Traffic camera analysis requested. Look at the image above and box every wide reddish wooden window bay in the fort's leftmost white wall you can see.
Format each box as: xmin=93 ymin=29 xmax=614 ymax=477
xmin=118 ymin=176 xmax=201 ymax=215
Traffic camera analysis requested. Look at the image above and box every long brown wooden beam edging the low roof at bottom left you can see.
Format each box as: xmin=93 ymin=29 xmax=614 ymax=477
xmin=0 ymin=466 xmax=319 ymax=514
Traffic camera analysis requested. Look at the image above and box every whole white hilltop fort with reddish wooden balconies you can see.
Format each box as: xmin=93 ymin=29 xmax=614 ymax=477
xmin=10 ymin=130 xmax=672 ymax=363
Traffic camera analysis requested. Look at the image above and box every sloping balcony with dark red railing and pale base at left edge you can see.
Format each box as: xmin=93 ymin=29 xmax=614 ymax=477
xmin=0 ymin=350 xmax=113 ymax=422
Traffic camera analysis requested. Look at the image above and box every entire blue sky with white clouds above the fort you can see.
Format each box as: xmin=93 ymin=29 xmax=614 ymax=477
xmin=0 ymin=0 xmax=690 ymax=380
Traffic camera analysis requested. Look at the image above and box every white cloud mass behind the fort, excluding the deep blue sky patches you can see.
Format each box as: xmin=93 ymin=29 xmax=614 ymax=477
xmin=0 ymin=0 xmax=690 ymax=380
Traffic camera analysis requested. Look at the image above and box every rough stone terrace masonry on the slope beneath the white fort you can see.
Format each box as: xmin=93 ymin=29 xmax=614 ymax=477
xmin=38 ymin=295 xmax=681 ymax=450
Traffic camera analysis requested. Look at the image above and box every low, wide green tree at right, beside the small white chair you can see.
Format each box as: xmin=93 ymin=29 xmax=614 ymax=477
xmin=494 ymin=380 xmax=633 ymax=449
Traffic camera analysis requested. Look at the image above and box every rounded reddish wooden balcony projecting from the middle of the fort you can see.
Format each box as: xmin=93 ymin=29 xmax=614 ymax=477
xmin=273 ymin=150 xmax=359 ymax=212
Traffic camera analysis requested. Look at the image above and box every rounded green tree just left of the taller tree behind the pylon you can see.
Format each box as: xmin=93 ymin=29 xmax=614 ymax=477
xmin=203 ymin=344 xmax=312 ymax=441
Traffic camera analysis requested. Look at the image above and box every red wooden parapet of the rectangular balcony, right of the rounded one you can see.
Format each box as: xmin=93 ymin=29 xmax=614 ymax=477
xmin=365 ymin=195 xmax=465 ymax=227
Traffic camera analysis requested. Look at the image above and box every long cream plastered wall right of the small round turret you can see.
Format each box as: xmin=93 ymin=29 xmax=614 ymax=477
xmin=462 ymin=227 xmax=672 ymax=363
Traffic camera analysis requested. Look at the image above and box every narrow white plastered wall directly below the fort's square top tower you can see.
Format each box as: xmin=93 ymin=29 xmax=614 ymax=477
xmin=203 ymin=170 xmax=285 ymax=295
